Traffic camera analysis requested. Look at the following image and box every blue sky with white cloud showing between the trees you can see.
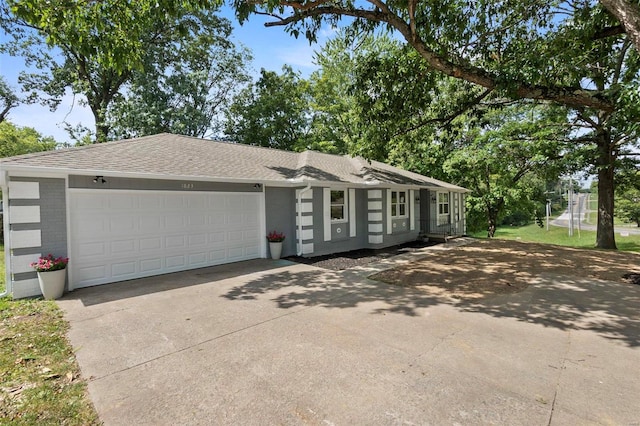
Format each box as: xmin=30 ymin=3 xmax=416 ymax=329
xmin=0 ymin=6 xmax=333 ymax=142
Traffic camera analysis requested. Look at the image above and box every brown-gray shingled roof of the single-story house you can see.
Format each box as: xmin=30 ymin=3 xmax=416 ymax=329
xmin=0 ymin=133 xmax=464 ymax=190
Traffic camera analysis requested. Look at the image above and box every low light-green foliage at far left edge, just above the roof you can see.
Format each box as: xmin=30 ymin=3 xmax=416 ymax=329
xmin=0 ymin=121 xmax=57 ymax=158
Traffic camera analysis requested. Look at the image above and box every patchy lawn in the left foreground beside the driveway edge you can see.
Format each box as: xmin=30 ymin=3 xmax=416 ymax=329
xmin=0 ymin=246 xmax=100 ymax=425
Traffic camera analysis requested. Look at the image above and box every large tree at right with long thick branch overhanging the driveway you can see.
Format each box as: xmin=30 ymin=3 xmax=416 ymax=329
xmin=234 ymin=0 xmax=640 ymax=248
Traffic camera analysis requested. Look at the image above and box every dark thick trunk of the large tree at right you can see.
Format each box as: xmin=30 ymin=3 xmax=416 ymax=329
xmin=596 ymin=130 xmax=616 ymax=250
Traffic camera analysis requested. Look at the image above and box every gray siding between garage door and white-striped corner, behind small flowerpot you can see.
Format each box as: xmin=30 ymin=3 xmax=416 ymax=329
xmin=265 ymin=187 xmax=297 ymax=257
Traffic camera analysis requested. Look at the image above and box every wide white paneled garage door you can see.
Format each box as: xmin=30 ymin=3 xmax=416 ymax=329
xmin=69 ymin=190 xmax=263 ymax=288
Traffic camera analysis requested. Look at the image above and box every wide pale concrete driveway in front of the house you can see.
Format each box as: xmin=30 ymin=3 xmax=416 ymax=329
xmin=59 ymin=250 xmax=640 ymax=425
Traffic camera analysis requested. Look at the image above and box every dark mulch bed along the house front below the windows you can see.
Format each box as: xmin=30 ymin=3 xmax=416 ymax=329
xmin=285 ymin=241 xmax=440 ymax=271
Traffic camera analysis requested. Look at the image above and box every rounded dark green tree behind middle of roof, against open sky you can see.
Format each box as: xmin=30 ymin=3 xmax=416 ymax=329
xmin=225 ymin=65 xmax=311 ymax=151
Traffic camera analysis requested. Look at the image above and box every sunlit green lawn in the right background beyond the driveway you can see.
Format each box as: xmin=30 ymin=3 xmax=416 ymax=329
xmin=472 ymin=224 xmax=640 ymax=252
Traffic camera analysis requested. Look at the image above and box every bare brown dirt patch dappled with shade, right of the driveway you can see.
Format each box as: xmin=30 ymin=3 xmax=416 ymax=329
xmin=370 ymin=240 xmax=640 ymax=299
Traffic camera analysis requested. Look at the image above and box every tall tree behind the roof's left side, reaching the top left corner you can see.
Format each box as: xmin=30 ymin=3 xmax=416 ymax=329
xmin=0 ymin=0 xmax=221 ymax=142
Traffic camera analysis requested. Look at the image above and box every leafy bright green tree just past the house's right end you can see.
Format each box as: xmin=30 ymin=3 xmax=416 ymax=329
xmin=444 ymin=104 xmax=569 ymax=237
